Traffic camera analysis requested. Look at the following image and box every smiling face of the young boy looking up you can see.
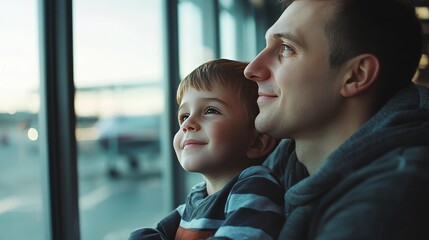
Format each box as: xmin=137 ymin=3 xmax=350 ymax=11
xmin=173 ymin=85 xmax=256 ymax=176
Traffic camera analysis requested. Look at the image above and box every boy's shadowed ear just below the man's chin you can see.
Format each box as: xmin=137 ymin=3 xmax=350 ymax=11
xmin=247 ymin=133 xmax=279 ymax=159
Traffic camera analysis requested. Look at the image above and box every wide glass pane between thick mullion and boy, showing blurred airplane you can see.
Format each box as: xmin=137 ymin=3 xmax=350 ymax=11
xmin=73 ymin=0 xmax=169 ymax=240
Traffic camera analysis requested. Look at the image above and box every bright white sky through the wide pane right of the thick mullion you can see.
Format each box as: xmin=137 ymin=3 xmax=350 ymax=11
xmin=73 ymin=0 xmax=164 ymax=86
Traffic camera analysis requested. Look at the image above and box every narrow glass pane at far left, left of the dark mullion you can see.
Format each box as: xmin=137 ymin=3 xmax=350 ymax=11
xmin=0 ymin=0 xmax=46 ymax=240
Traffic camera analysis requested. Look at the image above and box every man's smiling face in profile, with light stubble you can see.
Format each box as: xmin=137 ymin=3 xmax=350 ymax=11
xmin=245 ymin=0 xmax=341 ymax=139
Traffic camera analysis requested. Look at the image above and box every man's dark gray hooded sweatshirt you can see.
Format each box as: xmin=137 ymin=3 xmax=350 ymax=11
xmin=266 ymin=85 xmax=429 ymax=240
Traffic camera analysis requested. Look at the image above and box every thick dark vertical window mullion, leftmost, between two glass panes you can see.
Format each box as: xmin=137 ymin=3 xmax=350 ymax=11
xmin=39 ymin=0 xmax=80 ymax=240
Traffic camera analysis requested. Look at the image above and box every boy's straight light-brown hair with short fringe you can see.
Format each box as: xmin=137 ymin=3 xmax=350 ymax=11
xmin=176 ymin=59 xmax=259 ymax=128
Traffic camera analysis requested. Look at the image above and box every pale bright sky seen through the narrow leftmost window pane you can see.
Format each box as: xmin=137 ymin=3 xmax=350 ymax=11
xmin=0 ymin=0 xmax=39 ymax=112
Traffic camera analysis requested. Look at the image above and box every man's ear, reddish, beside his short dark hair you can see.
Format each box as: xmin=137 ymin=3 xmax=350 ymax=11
xmin=341 ymin=54 xmax=380 ymax=97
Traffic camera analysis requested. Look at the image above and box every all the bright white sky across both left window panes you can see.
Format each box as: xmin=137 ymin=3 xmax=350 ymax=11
xmin=0 ymin=0 xmax=165 ymax=114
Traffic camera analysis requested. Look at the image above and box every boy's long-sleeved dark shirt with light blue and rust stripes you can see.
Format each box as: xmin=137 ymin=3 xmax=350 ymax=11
xmin=129 ymin=166 xmax=284 ymax=240
